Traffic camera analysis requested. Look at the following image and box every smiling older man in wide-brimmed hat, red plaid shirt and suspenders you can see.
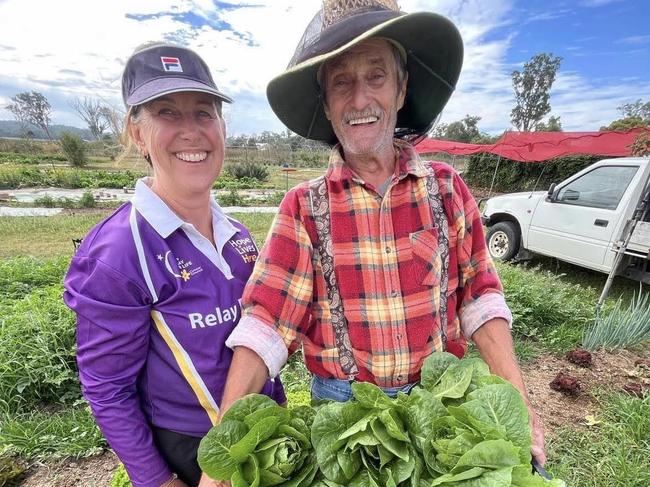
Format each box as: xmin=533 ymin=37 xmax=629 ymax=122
xmin=213 ymin=1 xmax=545 ymax=480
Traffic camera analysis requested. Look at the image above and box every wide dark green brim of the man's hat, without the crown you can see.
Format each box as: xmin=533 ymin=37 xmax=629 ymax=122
xmin=266 ymin=12 xmax=463 ymax=144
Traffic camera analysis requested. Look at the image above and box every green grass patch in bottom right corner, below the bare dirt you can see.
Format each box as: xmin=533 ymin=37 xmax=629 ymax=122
xmin=549 ymin=393 xmax=650 ymax=487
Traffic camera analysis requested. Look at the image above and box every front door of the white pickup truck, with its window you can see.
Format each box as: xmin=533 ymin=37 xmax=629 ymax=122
xmin=528 ymin=165 xmax=638 ymax=271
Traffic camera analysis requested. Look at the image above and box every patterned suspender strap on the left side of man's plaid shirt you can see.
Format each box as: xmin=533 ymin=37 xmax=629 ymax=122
xmin=309 ymin=176 xmax=359 ymax=380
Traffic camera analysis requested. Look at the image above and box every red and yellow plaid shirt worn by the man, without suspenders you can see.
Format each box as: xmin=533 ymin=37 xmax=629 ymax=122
xmin=229 ymin=142 xmax=511 ymax=387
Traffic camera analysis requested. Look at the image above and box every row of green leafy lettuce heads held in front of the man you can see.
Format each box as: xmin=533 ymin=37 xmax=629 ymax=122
xmin=199 ymin=352 xmax=565 ymax=487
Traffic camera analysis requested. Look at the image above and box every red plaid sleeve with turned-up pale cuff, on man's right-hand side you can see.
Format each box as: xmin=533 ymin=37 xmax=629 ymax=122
xmin=450 ymin=175 xmax=512 ymax=339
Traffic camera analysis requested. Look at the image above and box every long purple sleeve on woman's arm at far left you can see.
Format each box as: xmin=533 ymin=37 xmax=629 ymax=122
xmin=64 ymin=255 xmax=171 ymax=487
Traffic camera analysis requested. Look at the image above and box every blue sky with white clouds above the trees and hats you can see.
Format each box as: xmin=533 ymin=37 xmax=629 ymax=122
xmin=0 ymin=0 xmax=650 ymax=134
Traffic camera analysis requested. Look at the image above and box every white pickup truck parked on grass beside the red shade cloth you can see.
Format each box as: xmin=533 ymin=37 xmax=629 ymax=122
xmin=482 ymin=157 xmax=650 ymax=283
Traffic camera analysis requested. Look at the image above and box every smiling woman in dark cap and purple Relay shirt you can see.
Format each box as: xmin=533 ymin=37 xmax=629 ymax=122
xmin=64 ymin=43 xmax=285 ymax=487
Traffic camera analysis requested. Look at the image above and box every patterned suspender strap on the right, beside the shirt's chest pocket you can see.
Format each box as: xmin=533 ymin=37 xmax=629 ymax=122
xmin=426 ymin=164 xmax=449 ymax=349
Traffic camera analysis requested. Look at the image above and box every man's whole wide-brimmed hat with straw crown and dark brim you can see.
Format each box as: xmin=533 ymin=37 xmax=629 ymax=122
xmin=266 ymin=0 xmax=463 ymax=144
